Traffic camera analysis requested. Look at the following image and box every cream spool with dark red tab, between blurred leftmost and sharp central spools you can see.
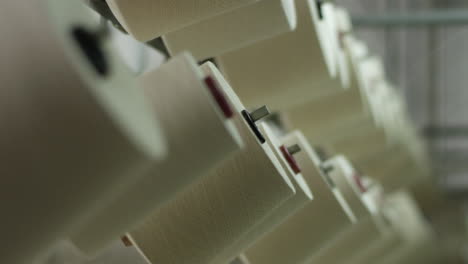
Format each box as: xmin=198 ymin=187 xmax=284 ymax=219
xmin=72 ymin=54 xmax=242 ymax=255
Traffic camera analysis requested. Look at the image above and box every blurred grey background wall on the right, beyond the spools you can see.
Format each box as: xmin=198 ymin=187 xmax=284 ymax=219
xmin=336 ymin=0 xmax=468 ymax=261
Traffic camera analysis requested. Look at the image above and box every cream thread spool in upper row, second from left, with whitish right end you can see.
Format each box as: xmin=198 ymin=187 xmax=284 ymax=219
xmin=163 ymin=0 xmax=297 ymax=60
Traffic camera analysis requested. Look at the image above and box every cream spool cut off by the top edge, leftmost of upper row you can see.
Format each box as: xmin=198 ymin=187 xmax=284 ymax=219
xmin=107 ymin=0 xmax=258 ymax=41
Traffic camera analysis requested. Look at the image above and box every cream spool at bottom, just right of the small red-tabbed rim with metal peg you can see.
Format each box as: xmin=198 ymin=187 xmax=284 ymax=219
xmin=245 ymin=131 xmax=353 ymax=264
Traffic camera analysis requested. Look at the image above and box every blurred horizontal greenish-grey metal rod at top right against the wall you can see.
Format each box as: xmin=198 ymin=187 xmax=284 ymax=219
xmin=352 ymin=9 xmax=468 ymax=27
